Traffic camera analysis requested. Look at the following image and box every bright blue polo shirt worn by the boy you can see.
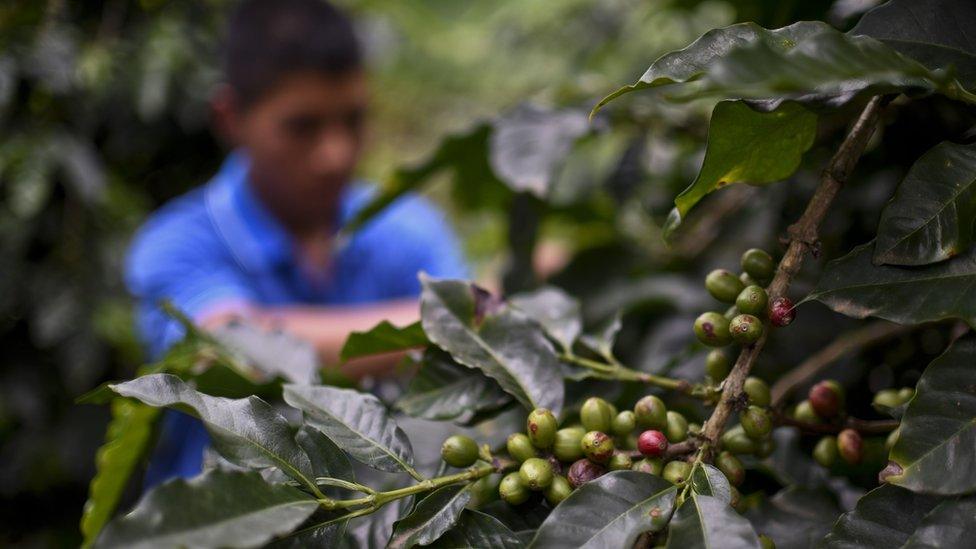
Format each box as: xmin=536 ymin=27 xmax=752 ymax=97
xmin=125 ymin=153 xmax=468 ymax=486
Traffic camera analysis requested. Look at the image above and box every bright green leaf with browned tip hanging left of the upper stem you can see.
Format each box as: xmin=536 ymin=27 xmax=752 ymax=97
xmin=665 ymin=101 xmax=817 ymax=236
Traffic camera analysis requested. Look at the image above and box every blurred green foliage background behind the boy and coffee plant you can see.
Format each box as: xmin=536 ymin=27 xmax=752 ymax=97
xmin=0 ymin=0 xmax=936 ymax=547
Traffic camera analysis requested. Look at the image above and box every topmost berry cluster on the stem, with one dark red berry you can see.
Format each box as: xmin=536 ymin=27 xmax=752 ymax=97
xmin=695 ymin=248 xmax=795 ymax=347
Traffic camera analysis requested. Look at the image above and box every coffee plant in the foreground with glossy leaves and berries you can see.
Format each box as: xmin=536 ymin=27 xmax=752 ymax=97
xmin=82 ymin=0 xmax=976 ymax=548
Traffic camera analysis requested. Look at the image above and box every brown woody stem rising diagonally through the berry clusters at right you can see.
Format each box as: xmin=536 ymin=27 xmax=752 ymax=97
xmin=702 ymin=96 xmax=883 ymax=458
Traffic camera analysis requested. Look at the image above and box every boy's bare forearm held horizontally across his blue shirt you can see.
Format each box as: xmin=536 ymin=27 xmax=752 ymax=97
xmin=199 ymin=298 xmax=420 ymax=379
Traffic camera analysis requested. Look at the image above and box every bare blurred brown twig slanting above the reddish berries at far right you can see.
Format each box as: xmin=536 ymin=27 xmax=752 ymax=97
xmin=771 ymin=321 xmax=912 ymax=408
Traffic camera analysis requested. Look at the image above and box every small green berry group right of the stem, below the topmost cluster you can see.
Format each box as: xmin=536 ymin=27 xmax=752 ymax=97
xmin=715 ymin=377 xmax=776 ymax=486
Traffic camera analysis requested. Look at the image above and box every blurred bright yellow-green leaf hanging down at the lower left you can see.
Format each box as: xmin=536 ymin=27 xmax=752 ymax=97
xmin=81 ymin=397 xmax=159 ymax=547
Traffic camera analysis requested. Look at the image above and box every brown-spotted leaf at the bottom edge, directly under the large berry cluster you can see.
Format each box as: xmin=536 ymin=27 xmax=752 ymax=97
xmin=529 ymin=471 xmax=678 ymax=548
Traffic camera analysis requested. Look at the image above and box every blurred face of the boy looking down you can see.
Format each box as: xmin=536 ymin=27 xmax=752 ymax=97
xmin=225 ymin=71 xmax=368 ymax=231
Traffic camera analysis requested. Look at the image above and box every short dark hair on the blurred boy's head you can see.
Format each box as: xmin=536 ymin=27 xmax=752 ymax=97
xmin=224 ymin=0 xmax=362 ymax=106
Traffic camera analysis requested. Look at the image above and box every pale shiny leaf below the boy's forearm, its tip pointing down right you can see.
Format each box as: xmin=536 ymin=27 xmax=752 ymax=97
xmin=284 ymin=385 xmax=419 ymax=476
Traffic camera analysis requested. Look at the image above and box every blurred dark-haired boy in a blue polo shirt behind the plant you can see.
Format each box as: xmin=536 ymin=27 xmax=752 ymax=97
xmin=126 ymin=0 xmax=466 ymax=486
